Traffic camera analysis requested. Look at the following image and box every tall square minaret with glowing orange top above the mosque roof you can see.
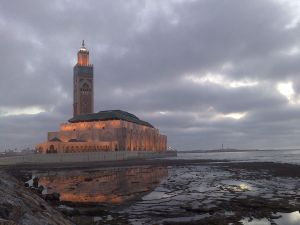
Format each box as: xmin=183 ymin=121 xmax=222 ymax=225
xmin=73 ymin=40 xmax=94 ymax=116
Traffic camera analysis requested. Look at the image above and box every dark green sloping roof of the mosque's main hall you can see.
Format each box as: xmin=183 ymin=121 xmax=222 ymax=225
xmin=69 ymin=110 xmax=154 ymax=128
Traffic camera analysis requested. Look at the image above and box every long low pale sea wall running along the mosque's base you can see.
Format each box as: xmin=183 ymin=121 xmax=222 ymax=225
xmin=0 ymin=151 xmax=176 ymax=166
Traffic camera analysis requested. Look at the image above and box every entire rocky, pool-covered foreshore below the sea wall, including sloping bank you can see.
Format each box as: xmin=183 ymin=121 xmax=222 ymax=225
xmin=0 ymin=159 xmax=300 ymax=225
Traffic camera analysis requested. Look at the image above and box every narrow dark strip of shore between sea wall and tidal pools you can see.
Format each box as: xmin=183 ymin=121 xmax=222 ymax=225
xmin=5 ymin=158 xmax=300 ymax=177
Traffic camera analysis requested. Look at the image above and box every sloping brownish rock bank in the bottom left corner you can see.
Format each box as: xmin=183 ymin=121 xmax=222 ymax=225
xmin=0 ymin=170 xmax=74 ymax=225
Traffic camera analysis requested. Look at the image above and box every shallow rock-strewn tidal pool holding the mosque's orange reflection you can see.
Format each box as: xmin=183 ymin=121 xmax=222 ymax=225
xmin=28 ymin=164 xmax=300 ymax=225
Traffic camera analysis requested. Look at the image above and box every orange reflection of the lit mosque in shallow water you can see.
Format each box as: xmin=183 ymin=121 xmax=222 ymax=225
xmin=35 ymin=167 xmax=168 ymax=204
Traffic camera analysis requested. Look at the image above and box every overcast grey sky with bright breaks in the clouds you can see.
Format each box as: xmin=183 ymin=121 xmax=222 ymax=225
xmin=0 ymin=0 xmax=300 ymax=151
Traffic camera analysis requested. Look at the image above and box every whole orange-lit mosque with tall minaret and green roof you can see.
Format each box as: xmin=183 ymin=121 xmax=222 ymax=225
xmin=36 ymin=41 xmax=167 ymax=153
